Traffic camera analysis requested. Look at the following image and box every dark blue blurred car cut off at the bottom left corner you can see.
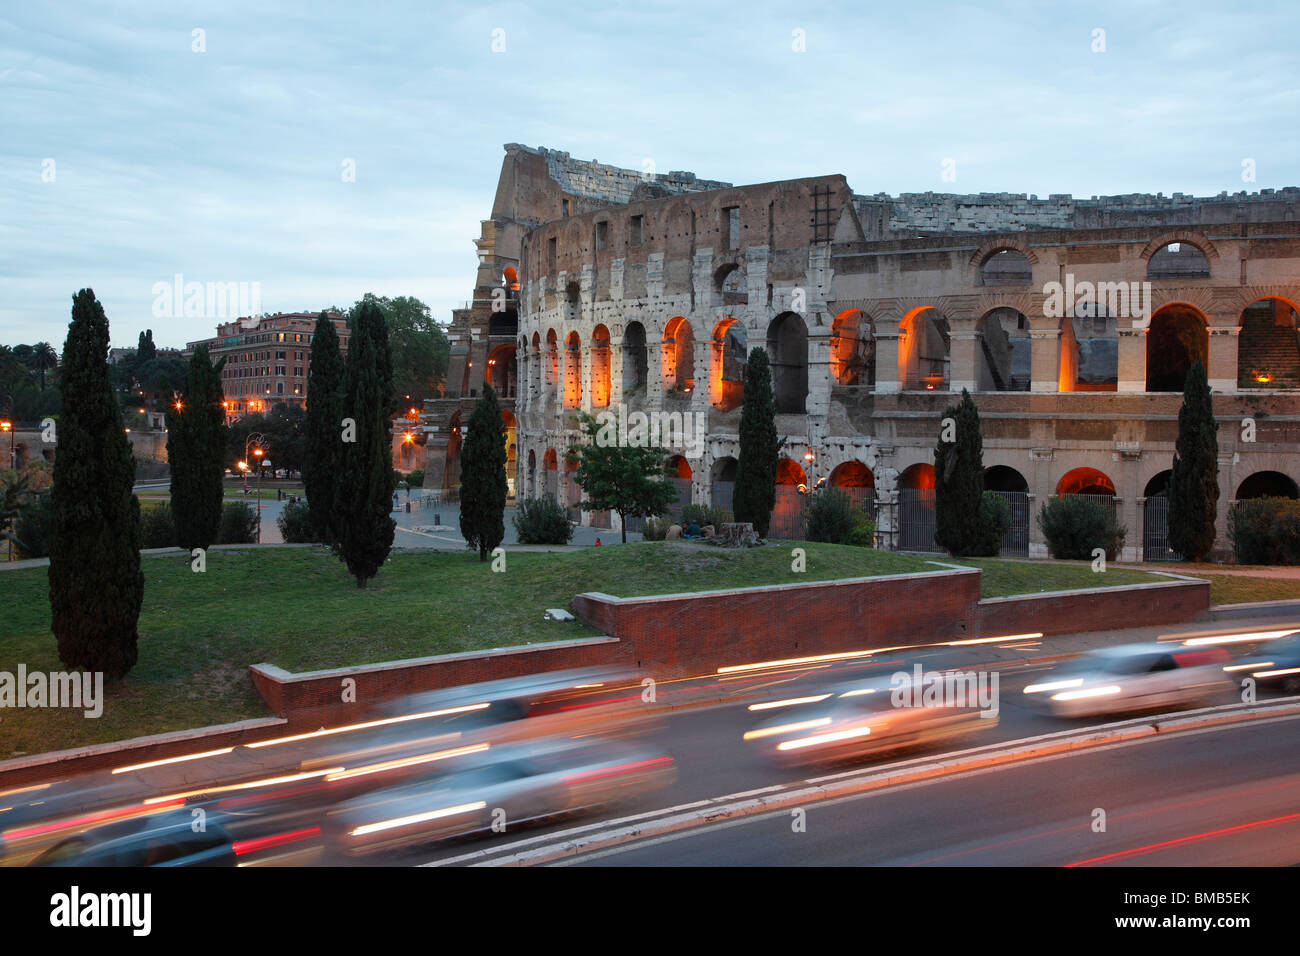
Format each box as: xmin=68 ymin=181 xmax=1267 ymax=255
xmin=27 ymin=810 xmax=239 ymax=866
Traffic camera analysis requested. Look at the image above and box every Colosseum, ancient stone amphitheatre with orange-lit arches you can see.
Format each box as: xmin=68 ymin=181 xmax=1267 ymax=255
xmin=421 ymin=144 xmax=1300 ymax=559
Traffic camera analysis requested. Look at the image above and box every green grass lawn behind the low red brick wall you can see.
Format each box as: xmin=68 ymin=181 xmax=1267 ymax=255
xmin=0 ymin=542 xmax=1180 ymax=758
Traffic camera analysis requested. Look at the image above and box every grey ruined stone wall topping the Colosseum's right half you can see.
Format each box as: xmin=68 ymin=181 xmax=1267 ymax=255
xmin=853 ymin=186 xmax=1300 ymax=241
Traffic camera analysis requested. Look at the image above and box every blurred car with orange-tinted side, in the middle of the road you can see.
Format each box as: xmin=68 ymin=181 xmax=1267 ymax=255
xmin=744 ymin=678 xmax=997 ymax=765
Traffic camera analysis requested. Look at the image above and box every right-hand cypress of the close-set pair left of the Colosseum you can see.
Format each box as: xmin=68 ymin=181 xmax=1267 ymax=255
xmin=334 ymin=302 xmax=397 ymax=588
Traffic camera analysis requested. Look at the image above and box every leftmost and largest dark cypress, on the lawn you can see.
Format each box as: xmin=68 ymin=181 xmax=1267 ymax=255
xmin=49 ymin=289 xmax=144 ymax=678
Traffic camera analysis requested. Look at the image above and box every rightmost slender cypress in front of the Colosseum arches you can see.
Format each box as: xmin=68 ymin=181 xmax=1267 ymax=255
xmin=1169 ymin=362 xmax=1218 ymax=561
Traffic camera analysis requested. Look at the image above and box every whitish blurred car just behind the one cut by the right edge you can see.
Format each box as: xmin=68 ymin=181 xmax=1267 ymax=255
xmin=1024 ymin=644 xmax=1232 ymax=717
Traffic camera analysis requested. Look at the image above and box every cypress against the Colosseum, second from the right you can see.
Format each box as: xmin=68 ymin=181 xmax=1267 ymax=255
xmin=935 ymin=389 xmax=984 ymax=557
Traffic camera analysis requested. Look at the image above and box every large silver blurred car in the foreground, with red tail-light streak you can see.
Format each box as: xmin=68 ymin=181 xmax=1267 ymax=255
xmin=325 ymin=741 xmax=676 ymax=856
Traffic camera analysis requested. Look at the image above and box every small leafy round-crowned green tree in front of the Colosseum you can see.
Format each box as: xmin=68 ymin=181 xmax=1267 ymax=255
xmin=566 ymin=412 xmax=677 ymax=544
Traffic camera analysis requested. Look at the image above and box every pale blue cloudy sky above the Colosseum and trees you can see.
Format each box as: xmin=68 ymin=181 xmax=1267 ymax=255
xmin=0 ymin=0 xmax=1300 ymax=347
